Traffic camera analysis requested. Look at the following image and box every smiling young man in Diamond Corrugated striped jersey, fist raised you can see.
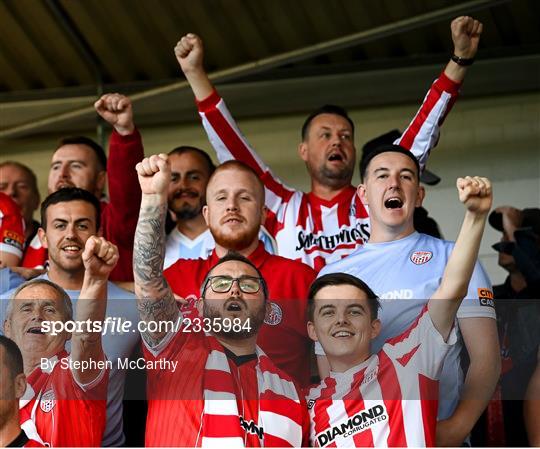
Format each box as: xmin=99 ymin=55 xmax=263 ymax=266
xmin=308 ymin=177 xmax=492 ymax=447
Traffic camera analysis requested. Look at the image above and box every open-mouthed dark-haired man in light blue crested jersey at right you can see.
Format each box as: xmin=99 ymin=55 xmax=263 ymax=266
xmin=316 ymin=145 xmax=500 ymax=446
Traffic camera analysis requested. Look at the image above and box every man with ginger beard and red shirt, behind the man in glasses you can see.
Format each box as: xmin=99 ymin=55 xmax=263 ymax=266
xmin=138 ymin=155 xmax=315 ymax=385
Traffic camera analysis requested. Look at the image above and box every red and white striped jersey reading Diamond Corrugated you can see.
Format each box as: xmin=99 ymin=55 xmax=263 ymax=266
xmin=307 ymin=307 xmax=457 ymax=447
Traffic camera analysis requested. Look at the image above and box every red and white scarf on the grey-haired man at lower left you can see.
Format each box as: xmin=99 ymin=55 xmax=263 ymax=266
xmin=19 ymin=350 xmax=68 ymax=443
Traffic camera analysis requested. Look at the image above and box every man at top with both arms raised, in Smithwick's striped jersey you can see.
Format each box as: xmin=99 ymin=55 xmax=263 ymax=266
xmin=175 ymin=17 xmax=482 ymax=271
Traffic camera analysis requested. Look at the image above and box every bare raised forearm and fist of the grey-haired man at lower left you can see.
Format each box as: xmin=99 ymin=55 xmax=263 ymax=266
xmin=71 ymin=237 xmax=118 ymax=384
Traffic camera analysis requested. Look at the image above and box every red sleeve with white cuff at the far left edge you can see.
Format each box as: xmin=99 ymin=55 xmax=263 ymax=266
xmin=0 ymin=194 xmax=24 ymax=258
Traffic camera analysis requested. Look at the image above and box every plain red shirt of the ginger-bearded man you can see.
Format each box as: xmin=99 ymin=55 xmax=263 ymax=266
xmin=164 ymin=242 xmax=317 ymax=386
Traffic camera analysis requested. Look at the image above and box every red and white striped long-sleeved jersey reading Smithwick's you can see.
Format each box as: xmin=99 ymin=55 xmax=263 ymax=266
xmin=198 ymin=73 xmax=460 ymax=271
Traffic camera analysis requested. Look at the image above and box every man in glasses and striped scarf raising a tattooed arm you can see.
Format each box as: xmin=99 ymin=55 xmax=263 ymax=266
xmin=133 ymin=155 xmax=307 ymax=447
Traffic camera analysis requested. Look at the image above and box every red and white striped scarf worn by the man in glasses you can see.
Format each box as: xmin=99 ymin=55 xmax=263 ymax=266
xmin=196 ymin=335 xmax=303 ymax=447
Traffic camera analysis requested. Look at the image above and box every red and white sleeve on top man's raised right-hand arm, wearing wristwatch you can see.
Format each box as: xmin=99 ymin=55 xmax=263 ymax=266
xmin=394 ymin=72 xmax=461 ymax=170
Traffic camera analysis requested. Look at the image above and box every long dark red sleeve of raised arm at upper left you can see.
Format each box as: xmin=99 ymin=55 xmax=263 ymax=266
xmin=101 ymin=130 xmax=144 ymax=282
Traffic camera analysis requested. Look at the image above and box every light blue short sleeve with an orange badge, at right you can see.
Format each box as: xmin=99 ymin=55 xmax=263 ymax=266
xmin=457 ymin=262 xmax=496 ymax=319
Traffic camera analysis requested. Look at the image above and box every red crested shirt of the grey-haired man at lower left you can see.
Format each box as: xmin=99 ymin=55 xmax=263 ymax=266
xmin=21 ymin=356 xmax=109 ymax=447
